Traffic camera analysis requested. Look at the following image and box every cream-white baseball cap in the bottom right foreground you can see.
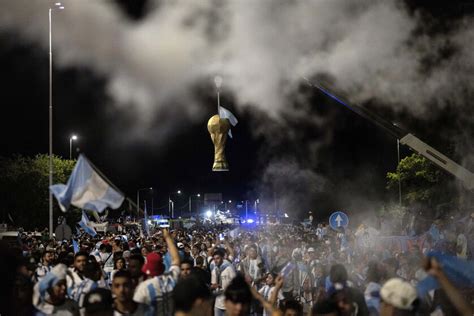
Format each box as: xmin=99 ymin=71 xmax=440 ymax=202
xmin=380 ymin=278 xmax=417 ymax=310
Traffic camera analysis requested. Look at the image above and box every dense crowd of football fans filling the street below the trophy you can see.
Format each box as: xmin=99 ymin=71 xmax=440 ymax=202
xmin=0 ymin=217 xmax=474 ymax=316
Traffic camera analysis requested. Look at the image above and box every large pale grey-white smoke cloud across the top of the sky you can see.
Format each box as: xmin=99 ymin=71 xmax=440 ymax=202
xmin=0 ymin=0 xmax=474 ymax=130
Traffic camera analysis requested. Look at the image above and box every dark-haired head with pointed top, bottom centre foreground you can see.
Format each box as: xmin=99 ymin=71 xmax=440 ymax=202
xmin=224 ymin=275 xmax=252 ymax=316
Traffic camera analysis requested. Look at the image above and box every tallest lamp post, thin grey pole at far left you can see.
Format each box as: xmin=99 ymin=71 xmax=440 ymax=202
xmin=48 ymin=2 xmax=64 ymax=238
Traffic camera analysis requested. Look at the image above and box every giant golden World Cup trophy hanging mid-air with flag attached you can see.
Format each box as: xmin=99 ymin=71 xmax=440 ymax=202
xmin=207 ymin=76 xmax=238 ymax=171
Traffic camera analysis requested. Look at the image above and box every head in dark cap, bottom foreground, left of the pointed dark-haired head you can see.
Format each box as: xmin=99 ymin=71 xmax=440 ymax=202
xmin=173 ymin=275 xmax=212 ymax=316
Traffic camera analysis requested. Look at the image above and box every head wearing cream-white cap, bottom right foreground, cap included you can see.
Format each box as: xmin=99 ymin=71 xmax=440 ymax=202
xmin=380 ymin=278 xmax=418 ymax=316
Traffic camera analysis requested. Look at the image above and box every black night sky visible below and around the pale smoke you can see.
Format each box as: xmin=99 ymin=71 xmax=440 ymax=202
xmin=0 ymin=0 xmax=473 ymax=218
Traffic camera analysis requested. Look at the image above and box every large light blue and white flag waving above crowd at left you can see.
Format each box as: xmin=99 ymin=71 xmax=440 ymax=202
xmin=49 ymin=155 xmax=124 ymax=213
